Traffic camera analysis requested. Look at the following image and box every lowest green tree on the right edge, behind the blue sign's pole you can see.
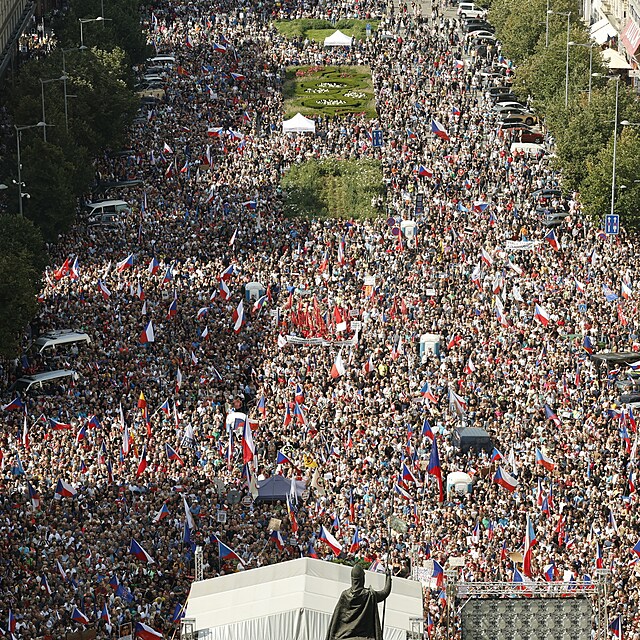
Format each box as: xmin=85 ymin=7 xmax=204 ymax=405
xmin=580 ymin=127 xmax=640 ymax=230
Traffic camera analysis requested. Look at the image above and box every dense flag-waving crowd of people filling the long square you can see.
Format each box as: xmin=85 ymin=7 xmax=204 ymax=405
xmin=0 ymin=0 xmax=640 ymax=640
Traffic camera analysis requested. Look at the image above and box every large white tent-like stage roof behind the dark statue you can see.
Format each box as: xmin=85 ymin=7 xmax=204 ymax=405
xmin=182 ymin=558 xmax=423 ymax=640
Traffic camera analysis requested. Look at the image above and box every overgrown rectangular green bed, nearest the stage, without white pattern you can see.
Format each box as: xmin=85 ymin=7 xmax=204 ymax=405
xmin=282 ymin=158 xmax=384 ymax=218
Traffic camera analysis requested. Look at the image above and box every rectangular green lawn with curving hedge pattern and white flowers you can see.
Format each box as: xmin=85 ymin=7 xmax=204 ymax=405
xmin=283 ymin=66 xmax=376 ymax=118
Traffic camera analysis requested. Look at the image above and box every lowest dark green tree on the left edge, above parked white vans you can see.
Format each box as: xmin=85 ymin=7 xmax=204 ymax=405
xmin=0 ymin=215 xmax=46 ymax=357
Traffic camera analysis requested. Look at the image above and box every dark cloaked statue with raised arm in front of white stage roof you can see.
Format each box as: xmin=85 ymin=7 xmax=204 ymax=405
xmin=326 ymin=564 xmax=391 ymax=640
